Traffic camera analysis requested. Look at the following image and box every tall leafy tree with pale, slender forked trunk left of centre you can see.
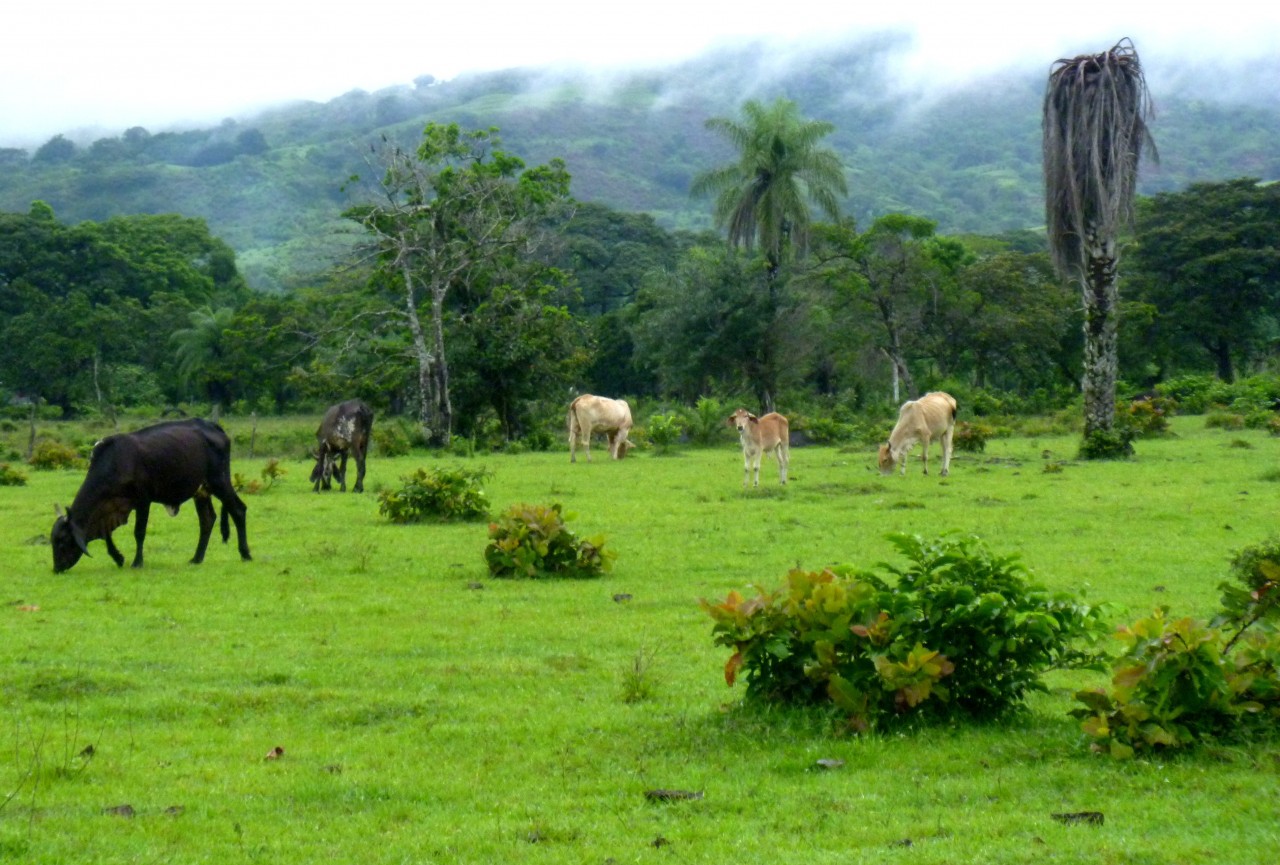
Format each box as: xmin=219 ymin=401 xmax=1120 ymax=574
xmin=347 ymin=123 xmax=570 ymax=445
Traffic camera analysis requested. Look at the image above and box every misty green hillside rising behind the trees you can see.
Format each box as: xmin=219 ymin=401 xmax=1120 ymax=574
xmin=0 ymin=38 xmax=1280 ymax=289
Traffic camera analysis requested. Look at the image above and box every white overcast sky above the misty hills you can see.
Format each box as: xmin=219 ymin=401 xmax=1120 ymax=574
xmin=0 ymin=0 xmax=1280 ymax=147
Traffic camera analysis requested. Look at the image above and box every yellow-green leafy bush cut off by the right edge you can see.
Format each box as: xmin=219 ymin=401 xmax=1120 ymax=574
xmin=1071 ymin=539 xmax=1280 ymax=759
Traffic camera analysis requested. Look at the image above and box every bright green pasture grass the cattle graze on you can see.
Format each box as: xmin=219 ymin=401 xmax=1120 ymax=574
xmin=0 ymin=417 xmax=1280 ymax=865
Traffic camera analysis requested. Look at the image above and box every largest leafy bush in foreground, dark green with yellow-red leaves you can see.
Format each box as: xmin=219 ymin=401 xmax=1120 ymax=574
xmin=703 ymin=534 xmax=1103 ymax=731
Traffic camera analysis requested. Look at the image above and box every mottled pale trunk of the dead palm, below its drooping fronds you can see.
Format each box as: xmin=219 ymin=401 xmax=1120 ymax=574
xmin=1080 ymin=226 xmax=1119 ymax=439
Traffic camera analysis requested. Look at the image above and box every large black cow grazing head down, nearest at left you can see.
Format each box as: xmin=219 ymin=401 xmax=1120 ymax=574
xmin=49 ymin=417 xmax=251 ymax=573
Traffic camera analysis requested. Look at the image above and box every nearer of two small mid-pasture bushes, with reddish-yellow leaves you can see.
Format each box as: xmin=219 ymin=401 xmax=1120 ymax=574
xmin=484 ymin=504 xmax=617 ymax=578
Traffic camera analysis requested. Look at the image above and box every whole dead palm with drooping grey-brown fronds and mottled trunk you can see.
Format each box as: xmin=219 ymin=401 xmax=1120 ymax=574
xmin=1043 ymin=38 xmax=1155 ymax=456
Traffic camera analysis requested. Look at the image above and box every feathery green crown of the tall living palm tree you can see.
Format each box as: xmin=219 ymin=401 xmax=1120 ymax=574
xmin=691 ymin=99 xmax=847 ymax=278
